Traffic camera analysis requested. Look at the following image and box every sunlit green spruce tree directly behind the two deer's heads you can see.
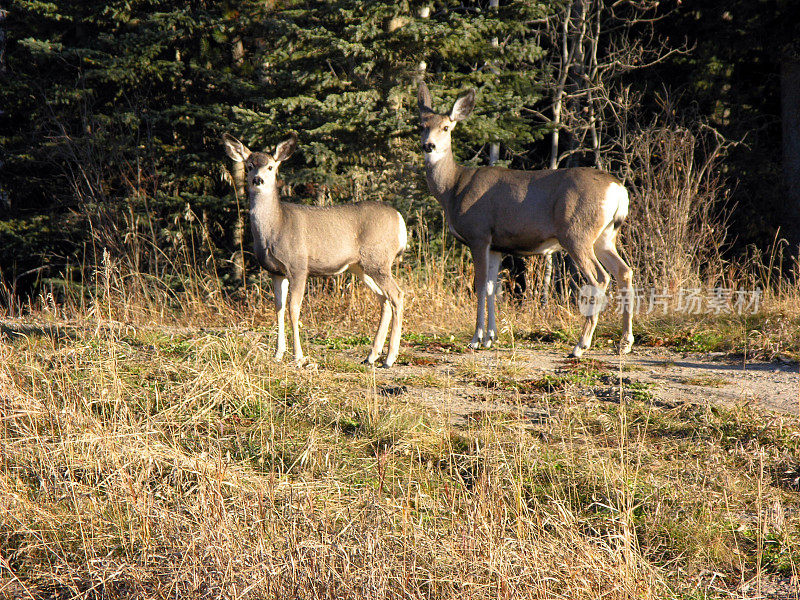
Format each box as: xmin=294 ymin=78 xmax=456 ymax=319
xmin=231 ymin=0 xmax=544 ymax=232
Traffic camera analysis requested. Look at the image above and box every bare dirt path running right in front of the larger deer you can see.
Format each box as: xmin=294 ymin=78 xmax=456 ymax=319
xmin=362 ymin=347 xmax=800 ymax=424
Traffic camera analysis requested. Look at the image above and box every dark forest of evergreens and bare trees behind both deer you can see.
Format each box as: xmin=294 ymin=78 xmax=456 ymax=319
xmin=0 ymin=0 xmax=800 ymax=294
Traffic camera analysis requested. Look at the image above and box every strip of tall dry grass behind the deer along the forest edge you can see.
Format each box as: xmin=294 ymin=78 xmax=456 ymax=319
xmin=6 ymin=190 xmax=800 ymax=358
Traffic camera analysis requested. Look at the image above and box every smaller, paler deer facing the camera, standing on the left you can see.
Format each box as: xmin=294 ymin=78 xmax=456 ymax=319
xmin=223 ymin=133 xmax=408 ymax=367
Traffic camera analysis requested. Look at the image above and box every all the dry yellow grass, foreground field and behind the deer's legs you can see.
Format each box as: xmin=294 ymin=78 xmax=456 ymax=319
xmin=0 ymin=256 xmax=800 ymax=599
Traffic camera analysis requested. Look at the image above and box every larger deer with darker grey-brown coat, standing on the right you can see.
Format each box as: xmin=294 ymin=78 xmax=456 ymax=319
xmin=417 ymin=82 xmax=633 ymax=357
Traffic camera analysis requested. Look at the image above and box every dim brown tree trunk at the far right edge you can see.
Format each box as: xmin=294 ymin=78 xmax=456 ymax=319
xmin=781 ymin=56 xmax=800 ymax=245
